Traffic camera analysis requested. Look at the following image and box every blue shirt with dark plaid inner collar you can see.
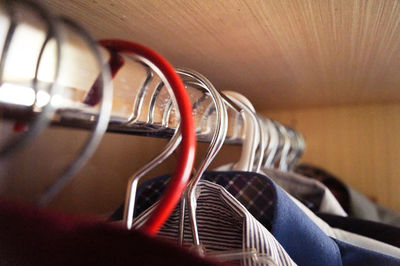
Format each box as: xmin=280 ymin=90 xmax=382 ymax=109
xmin=122 ymin=172 xmax=400 ymax=265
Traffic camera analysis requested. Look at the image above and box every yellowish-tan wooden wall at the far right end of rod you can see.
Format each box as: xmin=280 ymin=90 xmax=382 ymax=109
xmin=264 ymin=104 xmax=400 ymax=211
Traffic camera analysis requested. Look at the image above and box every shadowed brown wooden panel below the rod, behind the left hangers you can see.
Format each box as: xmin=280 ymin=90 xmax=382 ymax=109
xmin=0 ymin=128 xmax=241 ymax=217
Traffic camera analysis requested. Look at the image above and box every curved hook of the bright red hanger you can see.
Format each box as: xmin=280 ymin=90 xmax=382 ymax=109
xmin=99 ymin=40 xmax=196 ymax=235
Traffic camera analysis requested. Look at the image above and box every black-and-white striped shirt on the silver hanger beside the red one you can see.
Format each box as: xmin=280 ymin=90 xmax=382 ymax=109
xmin=134 ymin=180 xmax=296 ymax=265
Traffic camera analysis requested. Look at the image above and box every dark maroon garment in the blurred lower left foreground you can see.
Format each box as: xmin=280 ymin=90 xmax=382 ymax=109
xmin=0 ymin=199 xmax=225 ymax=265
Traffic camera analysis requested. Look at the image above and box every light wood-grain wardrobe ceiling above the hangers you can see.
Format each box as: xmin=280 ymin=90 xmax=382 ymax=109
xmin=44 ymin=0 xmax=400 ymax=109
